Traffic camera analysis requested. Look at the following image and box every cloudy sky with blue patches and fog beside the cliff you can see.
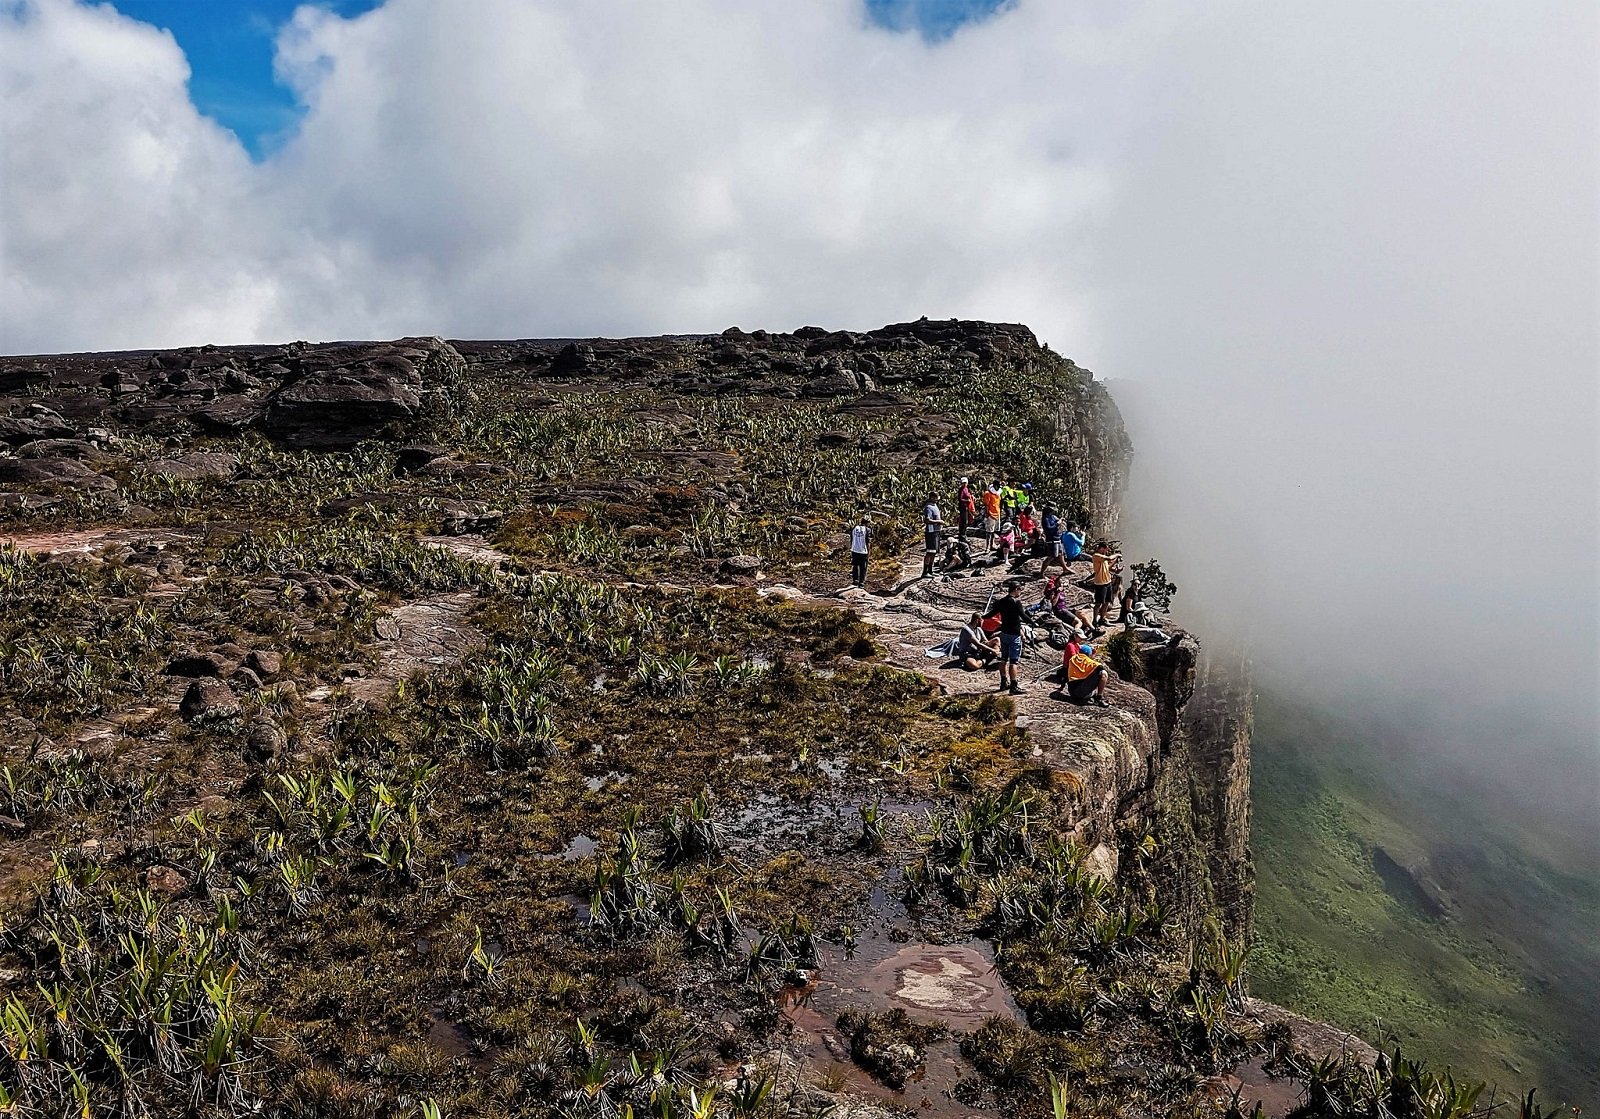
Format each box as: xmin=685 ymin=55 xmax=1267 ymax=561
xmin=0 ymin=0 xmax=1600 ymax=807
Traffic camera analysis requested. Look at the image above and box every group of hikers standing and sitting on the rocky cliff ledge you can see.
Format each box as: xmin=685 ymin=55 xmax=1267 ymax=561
xmin=850 ymin=477 xmax=1155 ymax=708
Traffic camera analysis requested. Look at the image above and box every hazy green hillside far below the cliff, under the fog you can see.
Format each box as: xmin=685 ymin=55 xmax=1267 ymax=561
xmin=1251 ymin=695 xmax=1600 ymax=1106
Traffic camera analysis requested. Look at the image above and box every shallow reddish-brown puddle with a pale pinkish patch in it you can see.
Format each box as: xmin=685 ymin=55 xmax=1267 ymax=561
xmin=781 ymin=937 xmax=1022 ymax=1119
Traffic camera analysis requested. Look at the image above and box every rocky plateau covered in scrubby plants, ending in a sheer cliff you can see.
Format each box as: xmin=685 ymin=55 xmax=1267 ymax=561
xmin=0 ymin=320 xmax=1376 ymax=1116
